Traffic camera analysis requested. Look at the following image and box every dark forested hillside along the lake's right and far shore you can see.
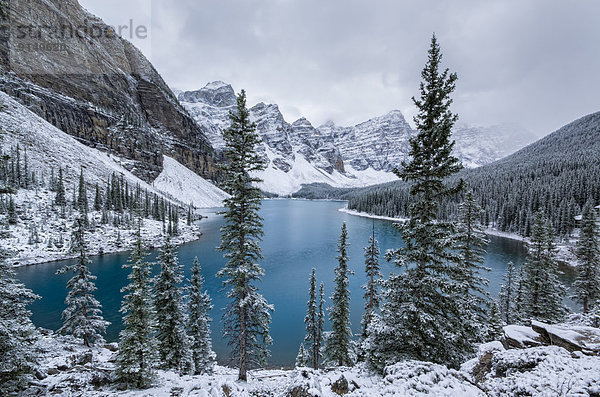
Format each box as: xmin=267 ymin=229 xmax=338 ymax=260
xmin=298 ymin=112 xmax=600 ymax=236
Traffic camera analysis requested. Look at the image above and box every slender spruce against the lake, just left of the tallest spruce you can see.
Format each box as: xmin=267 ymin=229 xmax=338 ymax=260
xmin=361 ymin=221 xmax=383 ymax=340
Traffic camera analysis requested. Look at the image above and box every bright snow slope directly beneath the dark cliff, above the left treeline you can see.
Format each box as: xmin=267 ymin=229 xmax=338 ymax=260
xmin=0 ymin=92 xmax=226 ymax=207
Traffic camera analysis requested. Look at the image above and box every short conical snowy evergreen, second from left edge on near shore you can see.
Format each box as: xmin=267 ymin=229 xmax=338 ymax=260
xmin=57 ymin=214 xmax=110 ymax=347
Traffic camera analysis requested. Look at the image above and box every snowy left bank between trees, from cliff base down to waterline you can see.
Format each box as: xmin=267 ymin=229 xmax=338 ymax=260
xmin=0 ymin=92 xmax=219 ymax=266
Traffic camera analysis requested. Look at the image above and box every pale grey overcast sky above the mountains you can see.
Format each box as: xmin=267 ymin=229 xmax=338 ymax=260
xmin=80 ymin=0 xmax=600 ymax=135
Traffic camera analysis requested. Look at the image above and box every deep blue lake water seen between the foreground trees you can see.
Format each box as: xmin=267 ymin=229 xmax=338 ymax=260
xmin=17 ymin=200 xmax=552 ymax=366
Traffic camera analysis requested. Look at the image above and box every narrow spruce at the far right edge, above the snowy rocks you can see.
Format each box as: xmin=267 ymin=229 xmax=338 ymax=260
xmin=573 ymin=201 xmax=600 ymax=313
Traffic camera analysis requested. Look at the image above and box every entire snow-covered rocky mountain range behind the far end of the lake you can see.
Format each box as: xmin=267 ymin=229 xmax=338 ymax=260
xmin=178 ymin=81 xmax=535 ymax=195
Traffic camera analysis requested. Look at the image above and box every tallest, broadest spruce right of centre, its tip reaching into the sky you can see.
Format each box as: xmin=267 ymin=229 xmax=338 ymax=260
xmin=365 ymin=35 xmax=473 ymax=369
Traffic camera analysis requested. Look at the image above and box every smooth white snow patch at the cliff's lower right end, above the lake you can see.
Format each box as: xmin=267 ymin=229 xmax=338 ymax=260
xmin=152 ymin=156 xmax=228 ymax=208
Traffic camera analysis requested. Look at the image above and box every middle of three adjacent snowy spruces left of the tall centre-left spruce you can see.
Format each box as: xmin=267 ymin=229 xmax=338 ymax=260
xmin=154 ymin=236 xmax=192 ymax=374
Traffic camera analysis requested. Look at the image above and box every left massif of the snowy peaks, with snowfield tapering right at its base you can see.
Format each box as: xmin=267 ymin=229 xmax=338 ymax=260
xmin=179 ymin=82 xmax=396 ymax=195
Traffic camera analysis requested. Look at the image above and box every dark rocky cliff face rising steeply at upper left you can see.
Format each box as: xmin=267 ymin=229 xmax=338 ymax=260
xmin=0 ymin=0 xmax=219 ymax=181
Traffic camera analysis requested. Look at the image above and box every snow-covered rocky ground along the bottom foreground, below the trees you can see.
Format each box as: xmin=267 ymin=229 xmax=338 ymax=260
xmin=27 ymin=325 xmax=600 ymax=397
